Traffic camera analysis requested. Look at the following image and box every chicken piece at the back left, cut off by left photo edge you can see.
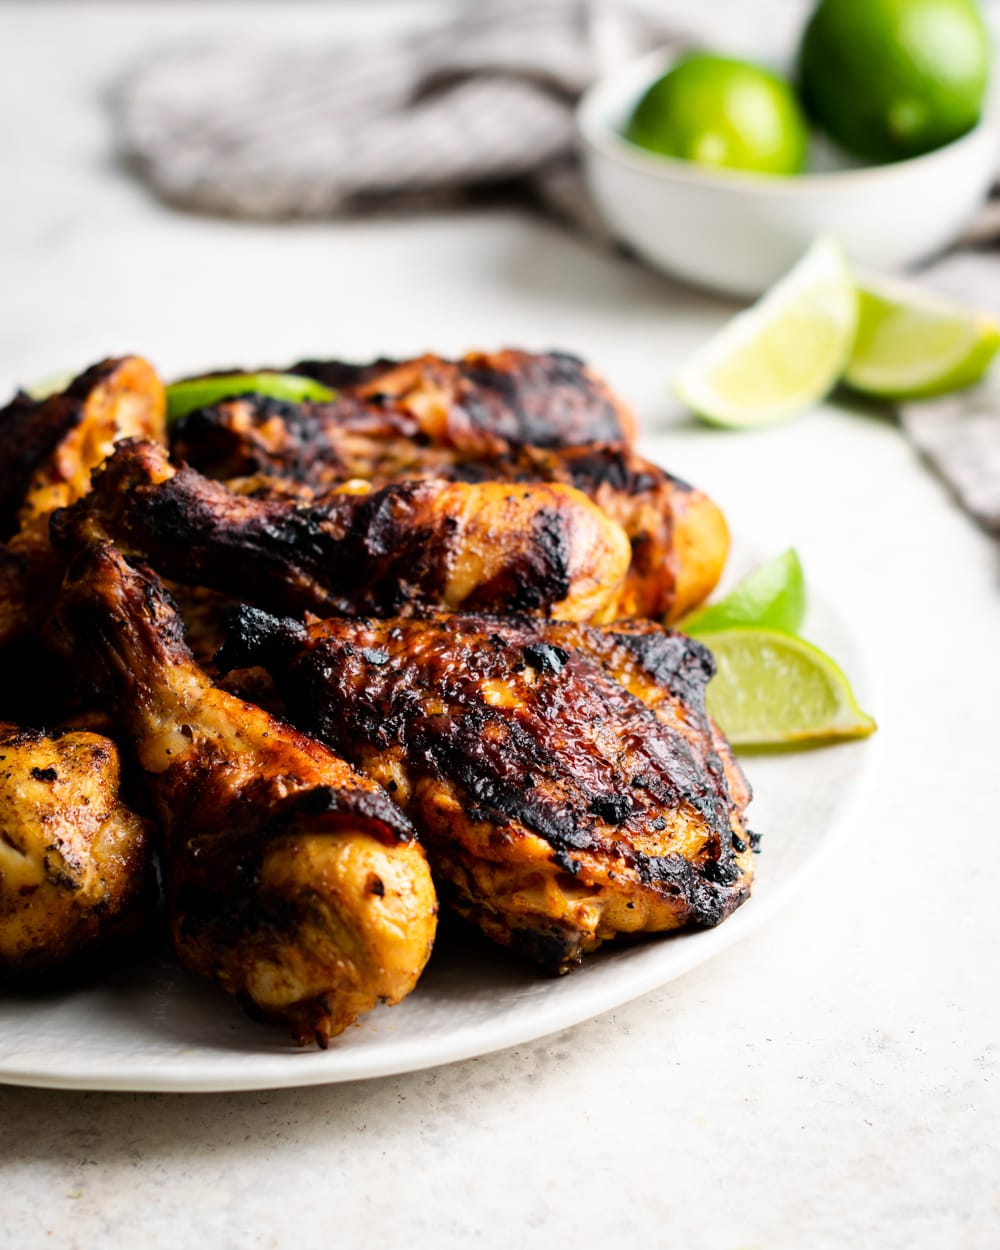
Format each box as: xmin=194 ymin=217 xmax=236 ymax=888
xmin=0 ymin=356 xmax=165 ymax=648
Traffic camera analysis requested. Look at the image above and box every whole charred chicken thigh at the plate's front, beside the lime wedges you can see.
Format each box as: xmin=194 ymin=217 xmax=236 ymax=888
xmin=219 ymin=609 xmax=751 ymax=971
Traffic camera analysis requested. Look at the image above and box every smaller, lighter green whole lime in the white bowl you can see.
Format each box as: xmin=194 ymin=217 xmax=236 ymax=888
xmin=625 ymin=53 xmax=806 ymax=174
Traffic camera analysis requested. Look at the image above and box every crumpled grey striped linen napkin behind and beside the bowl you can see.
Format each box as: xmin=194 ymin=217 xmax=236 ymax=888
xmin=123 ymin=0 xmax=1000 ymax=530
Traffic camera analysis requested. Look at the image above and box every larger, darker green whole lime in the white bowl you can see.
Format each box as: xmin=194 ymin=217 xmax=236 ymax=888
xmin=799 ymin=0 xmax=990 ymax=161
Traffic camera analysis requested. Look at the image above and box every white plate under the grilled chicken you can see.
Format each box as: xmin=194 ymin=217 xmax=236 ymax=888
xmin=0 ymin=577 xmax=873 ymax=1091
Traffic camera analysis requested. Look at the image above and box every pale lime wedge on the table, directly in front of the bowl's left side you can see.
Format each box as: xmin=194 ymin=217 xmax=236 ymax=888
xmin=676 ymin=239 xmax=858 ymax=429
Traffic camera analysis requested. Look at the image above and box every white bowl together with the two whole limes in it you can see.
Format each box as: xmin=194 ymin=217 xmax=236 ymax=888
xmin=578 ymin=0 xmax=1000 ymax=296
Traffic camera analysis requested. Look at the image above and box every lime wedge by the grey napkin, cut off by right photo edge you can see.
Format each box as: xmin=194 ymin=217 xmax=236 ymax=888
xmin=844 ymin=278 xmax=1000 ymax=399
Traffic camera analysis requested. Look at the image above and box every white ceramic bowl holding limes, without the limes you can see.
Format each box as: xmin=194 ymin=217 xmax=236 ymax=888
xmin=576 ymin=50 xmax=1000 ymax=295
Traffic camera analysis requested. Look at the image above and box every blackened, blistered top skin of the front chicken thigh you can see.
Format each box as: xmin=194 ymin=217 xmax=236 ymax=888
xmin=222 ymin=614 xmax=740 ymax=924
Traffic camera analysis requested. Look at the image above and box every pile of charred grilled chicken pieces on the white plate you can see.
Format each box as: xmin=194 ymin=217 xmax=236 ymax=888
xmin=0 ymin=350 xmax=754 ymax=1046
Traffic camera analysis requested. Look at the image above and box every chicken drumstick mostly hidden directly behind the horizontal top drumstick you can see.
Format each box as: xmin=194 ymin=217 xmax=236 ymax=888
xmin=173 ymin=384 xmax=729 ymax=623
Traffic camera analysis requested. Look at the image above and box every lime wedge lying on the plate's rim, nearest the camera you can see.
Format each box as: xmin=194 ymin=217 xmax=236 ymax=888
xmin=699 ymin=629 xmax=875 ymax=746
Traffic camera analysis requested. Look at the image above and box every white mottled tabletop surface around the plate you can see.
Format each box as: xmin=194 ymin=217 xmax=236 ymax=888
xmin=0 ymin=4 xmax=1000 ymax=1250
